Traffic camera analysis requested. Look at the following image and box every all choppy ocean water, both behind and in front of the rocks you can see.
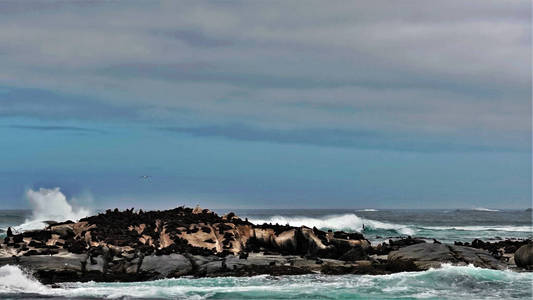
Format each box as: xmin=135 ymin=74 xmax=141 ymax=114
xmin=0 ymin=208 xmax=533 ymax=299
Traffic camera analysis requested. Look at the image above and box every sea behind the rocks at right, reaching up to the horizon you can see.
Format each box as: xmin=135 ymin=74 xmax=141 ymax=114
xmin=236 ymin=208 xmax=533 ymax=243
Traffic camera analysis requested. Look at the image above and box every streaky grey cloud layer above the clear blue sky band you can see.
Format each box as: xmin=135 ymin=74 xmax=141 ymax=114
xmin=0 ymin=1 xmax=531 ymax=147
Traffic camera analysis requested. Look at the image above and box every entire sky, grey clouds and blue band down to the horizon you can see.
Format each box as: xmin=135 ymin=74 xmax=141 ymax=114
xmin=0 ymin=0 xmax=532 ymax=209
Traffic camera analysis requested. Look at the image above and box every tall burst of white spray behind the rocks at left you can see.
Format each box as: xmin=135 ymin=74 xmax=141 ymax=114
xmin=13 ymin=187 xmax=91 ymax=232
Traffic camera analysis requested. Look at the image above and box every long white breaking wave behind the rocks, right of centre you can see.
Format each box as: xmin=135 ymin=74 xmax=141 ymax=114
xmin=249 ymin=214 xmax=415 ymax=235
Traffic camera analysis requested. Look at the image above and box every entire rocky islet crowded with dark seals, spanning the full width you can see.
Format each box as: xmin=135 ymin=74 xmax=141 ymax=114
xmin=0 ymin=207 xmax=533 ymax=284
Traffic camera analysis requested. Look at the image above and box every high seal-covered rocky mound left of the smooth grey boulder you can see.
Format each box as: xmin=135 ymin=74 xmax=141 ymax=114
xmin=0 ymin=207 xmax=370 ymax=282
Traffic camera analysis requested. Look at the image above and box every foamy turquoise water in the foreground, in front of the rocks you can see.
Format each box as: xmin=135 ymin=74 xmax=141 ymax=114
xmin=0 ymin=266 xmax=533 ymax=299
